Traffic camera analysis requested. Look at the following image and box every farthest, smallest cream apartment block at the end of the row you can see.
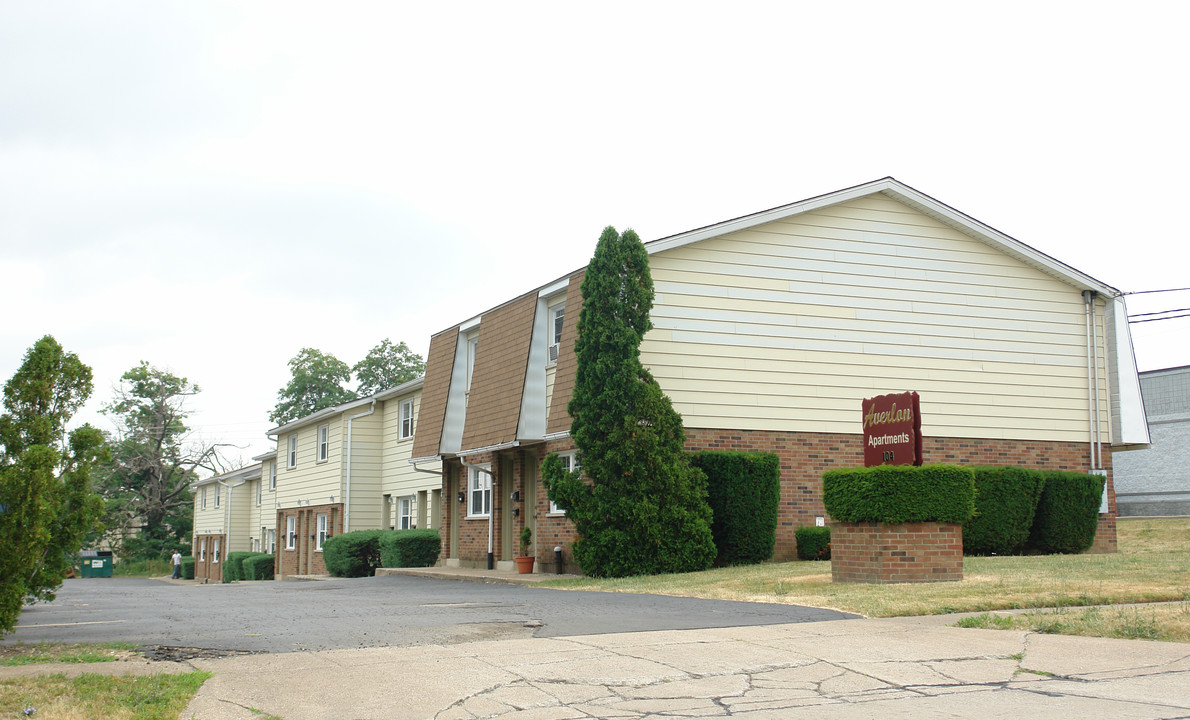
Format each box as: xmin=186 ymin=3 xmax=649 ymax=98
xmin=190 ymin=463 xmax=262 ymax=582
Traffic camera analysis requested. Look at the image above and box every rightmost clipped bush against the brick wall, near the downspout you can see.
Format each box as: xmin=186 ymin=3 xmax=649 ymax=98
xmin=1027 ymin=470 xmax=1104 ymax=553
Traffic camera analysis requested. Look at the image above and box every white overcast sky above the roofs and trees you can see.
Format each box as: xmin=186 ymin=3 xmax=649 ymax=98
xmin=0 ymin=0 xmax=1190 ymax=459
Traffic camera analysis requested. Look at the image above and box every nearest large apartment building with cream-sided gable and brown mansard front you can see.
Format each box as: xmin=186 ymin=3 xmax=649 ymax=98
xmin=412 ymin=179 xmax=1148 ymax=571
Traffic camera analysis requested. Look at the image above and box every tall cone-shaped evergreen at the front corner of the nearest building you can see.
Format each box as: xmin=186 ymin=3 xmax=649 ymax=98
xmin=543 ymin=227 xmax=715 ymax=577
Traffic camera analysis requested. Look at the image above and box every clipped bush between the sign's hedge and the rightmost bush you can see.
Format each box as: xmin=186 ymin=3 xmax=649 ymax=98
xmin=963 ymin=467 xmax=1045 ymax=555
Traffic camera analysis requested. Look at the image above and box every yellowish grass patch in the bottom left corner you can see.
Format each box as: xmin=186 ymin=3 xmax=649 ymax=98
xmin=0 ymin=671 xmax=211 ymax=720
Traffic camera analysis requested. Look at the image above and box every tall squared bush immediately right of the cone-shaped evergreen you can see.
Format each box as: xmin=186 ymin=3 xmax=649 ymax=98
xmin=690 ymin=450 xmax=781 ymax=565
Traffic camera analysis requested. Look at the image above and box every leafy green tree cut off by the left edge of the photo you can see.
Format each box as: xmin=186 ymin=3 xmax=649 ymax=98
xmin=0 ymin=336 xmax=104 ymax=633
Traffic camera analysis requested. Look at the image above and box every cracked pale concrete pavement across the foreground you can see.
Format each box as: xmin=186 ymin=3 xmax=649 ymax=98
xmin=182 ymin=616 xmax=1190 ymax=720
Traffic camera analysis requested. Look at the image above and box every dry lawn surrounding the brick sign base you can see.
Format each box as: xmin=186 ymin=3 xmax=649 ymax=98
xmin=549 ymin=518 xmax=1190 ymax=618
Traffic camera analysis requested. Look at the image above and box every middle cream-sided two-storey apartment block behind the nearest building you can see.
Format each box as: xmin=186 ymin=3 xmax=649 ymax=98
xmin=261 ymin=377 xmax=440 ymax=580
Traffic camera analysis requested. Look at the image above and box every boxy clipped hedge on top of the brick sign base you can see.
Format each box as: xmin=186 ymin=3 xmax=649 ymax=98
xmin=822 ymin=465 xmax=975 ymax=525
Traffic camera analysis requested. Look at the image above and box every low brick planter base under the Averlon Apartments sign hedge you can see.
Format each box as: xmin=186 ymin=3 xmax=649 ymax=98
xmin=831 ymin=522 xmax=963 ymax=584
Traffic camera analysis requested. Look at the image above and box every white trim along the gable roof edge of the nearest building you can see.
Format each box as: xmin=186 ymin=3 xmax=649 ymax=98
xmin=645 ymin=177 xmax=1120 ymax=296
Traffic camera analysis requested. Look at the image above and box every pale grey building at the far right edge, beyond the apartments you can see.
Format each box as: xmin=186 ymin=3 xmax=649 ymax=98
xmin=1115 ymin=365 xmax=1190 ymax=516
